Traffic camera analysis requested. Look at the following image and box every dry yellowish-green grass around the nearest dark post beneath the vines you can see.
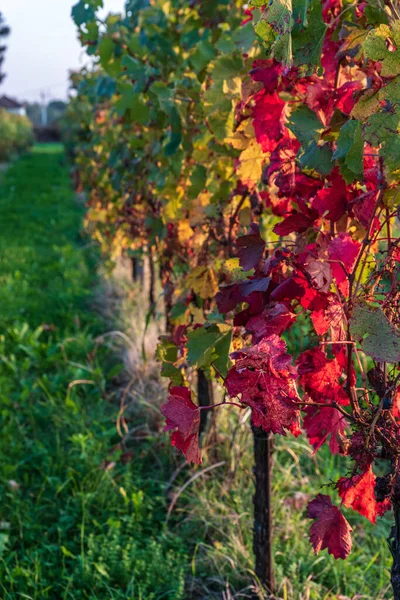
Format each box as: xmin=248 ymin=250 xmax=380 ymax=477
xmin=178 ymin=424 xmax=393 ymax=600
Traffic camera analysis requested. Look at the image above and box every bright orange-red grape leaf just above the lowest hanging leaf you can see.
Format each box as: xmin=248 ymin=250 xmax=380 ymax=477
xmin=337 ymin=467 xmax=391 ymax=523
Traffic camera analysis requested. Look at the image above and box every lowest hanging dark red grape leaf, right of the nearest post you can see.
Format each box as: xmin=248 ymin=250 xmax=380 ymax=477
xmin=307 ymin=494 xmax=353 ymax=559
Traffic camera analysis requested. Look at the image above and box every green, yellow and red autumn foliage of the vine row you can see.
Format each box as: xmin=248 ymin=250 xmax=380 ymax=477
xmin=73 ymin=0 xmax=400 ymax=580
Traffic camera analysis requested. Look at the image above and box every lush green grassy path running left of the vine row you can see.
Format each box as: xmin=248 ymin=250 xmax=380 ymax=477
xmin=0 ymin=145 xmax=187 ymax=600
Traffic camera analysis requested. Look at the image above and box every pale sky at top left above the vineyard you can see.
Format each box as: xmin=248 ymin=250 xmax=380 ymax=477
xmin=0 ymin=0 xmax=125 ymax=101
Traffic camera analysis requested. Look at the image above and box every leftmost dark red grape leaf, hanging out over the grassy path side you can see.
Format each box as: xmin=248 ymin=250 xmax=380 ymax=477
xmin=161 ymin=387 xmax=201 ymax=465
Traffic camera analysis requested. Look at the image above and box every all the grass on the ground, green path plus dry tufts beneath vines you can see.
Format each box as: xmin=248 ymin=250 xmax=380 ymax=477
xmin=0 ymin=145 xmax=392 ymax=600
